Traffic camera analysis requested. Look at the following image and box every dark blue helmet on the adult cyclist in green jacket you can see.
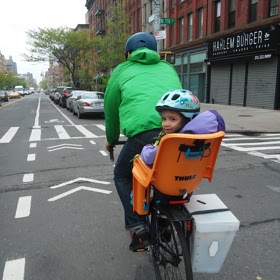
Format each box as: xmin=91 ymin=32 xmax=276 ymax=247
xmin=125 ymin=32 xmax=157 ymax=53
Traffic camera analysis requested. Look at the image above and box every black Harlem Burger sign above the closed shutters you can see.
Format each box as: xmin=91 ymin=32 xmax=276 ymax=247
xmin=208 ymin=26 xmax=280 ymax=59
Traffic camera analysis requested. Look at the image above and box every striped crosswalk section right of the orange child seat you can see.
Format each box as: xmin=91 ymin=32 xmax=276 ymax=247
xmin=222 ymin=133 xmax=280 ymax=163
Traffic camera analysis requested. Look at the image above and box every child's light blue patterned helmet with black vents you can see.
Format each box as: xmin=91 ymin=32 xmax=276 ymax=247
xmin=156 ymin=89 xmax=200 ymax=119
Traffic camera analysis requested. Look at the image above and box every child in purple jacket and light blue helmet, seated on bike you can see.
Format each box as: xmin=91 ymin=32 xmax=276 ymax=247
xmin=141 ymin=89 xmax=225 ymax=166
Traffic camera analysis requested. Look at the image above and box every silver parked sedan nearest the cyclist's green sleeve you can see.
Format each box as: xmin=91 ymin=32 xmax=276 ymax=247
xmin=73 ymin=91 xmax=104 ymax=119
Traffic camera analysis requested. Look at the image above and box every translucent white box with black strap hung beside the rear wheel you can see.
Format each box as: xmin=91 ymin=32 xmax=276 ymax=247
xmin=185 ymin=194 xmax=240 ymax=273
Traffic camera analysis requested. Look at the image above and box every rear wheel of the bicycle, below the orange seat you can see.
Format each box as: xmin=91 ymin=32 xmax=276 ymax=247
xmin=151 ymin=210 xmax=193 ymax=280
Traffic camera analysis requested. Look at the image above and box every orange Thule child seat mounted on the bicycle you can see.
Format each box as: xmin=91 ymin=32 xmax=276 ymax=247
xmin=132 ymin=131 xmax=225 ymax=214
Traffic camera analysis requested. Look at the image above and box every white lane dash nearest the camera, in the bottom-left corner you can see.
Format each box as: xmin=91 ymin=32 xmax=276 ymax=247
xmin=2 ymin=258 xmax=25 ymax=280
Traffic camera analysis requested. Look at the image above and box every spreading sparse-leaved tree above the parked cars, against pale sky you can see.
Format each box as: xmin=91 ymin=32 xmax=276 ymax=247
xmin=24 ymin=27 xmax=94 ymax=86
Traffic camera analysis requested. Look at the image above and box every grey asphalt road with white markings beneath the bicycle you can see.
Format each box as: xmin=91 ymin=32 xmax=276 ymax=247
xmin=0 ymin=94 xmax=280 ymax=280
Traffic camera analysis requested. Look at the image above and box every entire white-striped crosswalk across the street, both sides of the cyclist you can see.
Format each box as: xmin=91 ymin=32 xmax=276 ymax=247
xmin=0 ymin=124 xmax=280 ymax=163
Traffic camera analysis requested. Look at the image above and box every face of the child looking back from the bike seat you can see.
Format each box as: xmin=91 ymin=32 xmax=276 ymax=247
xmin=161 ymin=110 xmax=183 ymax=134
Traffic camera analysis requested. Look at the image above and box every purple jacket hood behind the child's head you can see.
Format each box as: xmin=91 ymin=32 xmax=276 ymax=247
xmin=180 ymin=110 xmax=226 ymax=134
